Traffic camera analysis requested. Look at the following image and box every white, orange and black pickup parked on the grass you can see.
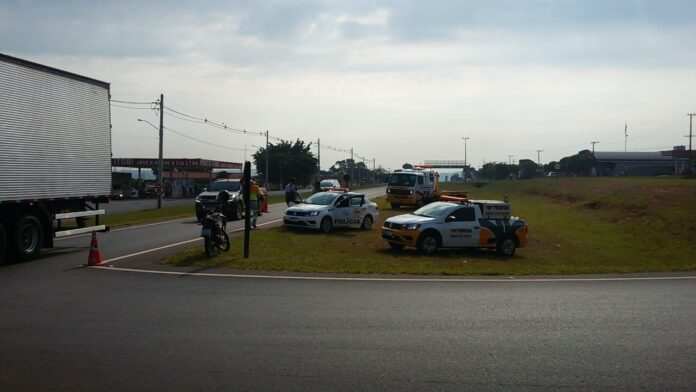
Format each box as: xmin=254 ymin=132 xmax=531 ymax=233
xmin=381 ymin=200 xmax=527 ymax=257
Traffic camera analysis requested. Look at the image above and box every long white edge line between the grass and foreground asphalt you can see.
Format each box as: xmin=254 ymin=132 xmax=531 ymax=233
xmin=89 ymin=266 xmax=696 ymax=283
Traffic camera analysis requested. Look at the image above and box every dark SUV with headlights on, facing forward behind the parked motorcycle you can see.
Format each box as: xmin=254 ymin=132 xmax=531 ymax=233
xmin=196 ymin=180 xmax=244 ymax=221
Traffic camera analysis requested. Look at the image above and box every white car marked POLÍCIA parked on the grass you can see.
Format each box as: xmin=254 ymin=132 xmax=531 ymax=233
xmin=283 ymin=191 xmax=379 ymax=233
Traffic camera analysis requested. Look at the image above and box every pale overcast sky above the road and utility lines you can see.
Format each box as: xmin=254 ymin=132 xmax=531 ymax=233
xmin=0 ymin=0 xmax=696 ymax=169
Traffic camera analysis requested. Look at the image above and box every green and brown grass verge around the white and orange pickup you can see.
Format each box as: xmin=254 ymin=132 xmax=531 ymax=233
xmin=165 ymin=178 xmax=696 ymax=275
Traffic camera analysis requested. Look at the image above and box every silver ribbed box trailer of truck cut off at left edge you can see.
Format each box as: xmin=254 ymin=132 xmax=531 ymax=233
xmin=0 ymin=53 xmax=111 ymax=263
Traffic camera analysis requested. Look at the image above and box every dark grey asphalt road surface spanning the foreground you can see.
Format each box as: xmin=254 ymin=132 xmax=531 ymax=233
xmin=0 ymin=188 xmax=696 ymax=391
